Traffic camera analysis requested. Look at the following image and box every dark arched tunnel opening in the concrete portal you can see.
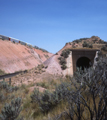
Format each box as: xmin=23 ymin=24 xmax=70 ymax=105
xmin=76 ymin=57 xmax=91 ymax=70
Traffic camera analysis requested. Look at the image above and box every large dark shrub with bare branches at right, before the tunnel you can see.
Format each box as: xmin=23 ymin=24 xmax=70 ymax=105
xmin=54 ymin=58 xmax=107 ymax=120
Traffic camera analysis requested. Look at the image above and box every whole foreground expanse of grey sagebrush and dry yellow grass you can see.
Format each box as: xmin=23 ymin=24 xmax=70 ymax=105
xmin=0 ymin=57 xmax=107 ymax=120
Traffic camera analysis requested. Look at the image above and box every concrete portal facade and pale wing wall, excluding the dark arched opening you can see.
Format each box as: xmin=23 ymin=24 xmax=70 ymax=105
xmin=64 ymin=49 xmax=98 ymax=75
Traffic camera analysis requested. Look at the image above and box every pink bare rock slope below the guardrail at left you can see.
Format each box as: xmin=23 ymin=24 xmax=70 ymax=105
xmin=0 ymin=39 xmax=52 ymax=73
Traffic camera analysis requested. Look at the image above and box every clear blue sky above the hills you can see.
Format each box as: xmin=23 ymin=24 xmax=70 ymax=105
xmin=0 ymin=0 xmax=107 ymax=53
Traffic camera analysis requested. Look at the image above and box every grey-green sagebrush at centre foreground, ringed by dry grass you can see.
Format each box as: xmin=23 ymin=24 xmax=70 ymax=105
xmin=31 ymin=88 xmax=62 ymax=113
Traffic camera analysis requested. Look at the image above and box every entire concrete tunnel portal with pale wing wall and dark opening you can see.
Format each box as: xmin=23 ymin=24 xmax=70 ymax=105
xmin=64 ymin=48 xmax=99 ymax=75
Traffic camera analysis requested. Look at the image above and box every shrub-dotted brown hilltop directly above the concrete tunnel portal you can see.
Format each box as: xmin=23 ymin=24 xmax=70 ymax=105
xmin=63 ymin=36 xmax=107 ymax=51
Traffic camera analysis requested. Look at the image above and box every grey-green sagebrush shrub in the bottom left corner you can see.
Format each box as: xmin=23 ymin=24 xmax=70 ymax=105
xmin=0 ymin=98 xmax=21 ymax=120
